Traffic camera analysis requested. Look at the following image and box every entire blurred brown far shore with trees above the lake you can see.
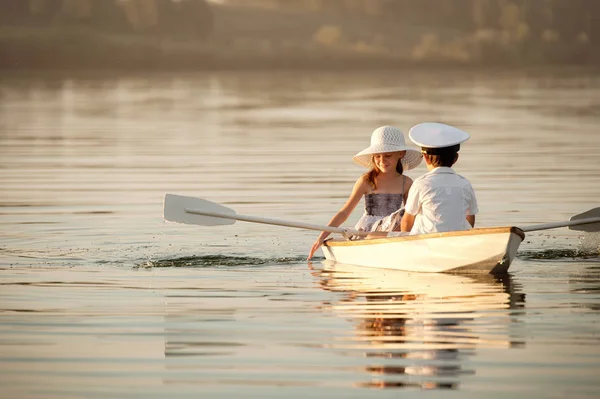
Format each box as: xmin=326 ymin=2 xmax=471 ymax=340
xmin=0 ymin=0 xmax=600 ymax=68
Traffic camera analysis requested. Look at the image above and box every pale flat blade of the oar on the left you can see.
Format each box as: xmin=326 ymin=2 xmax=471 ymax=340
xmin=163 ymin=194 xmax=235 ymax=226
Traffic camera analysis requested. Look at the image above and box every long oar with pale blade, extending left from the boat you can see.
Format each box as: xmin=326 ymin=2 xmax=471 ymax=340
xmin=164 ymin=194 xmax=368 ymax=237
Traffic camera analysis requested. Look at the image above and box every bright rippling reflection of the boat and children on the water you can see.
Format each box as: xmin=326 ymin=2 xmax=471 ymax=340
xmin=316 ymin=263 xmax=525 ymax=389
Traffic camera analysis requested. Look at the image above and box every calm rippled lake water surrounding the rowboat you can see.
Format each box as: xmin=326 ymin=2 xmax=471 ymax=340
xmin=0 ymin=69 xmax=600 ymax=398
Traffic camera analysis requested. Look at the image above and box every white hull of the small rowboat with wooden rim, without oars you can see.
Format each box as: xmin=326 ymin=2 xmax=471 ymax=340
xmin=323 ymin=227 xmax=525 ymax=274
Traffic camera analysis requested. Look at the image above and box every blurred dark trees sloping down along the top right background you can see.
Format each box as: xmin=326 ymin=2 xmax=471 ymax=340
xmin=226 ymin=0 xmax=600 ymax=46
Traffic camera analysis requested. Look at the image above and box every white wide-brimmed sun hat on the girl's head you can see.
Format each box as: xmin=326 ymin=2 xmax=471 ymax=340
xmin=352 ymin=126 xmax=423 ymax=170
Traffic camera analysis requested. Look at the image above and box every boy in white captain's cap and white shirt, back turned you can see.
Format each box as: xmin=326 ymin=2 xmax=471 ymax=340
xmin=369 ymin=123 xmax=479 ymax=237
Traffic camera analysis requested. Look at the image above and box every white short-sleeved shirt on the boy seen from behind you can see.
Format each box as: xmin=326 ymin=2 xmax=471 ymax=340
xmin=405 ymin=167 xmax=479 ymax=234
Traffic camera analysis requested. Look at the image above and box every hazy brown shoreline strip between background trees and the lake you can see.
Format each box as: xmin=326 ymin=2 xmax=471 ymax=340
xmin=0 ymin=2 xmax=600 ymax=71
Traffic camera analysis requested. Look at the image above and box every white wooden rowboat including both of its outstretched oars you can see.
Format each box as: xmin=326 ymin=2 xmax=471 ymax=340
xmin=164 ymin=194 xmax=600 ymax=274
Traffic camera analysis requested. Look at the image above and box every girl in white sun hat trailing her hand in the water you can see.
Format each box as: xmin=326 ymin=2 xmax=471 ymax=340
xmin=308 ymin=126 xmax=423 ymax=259
